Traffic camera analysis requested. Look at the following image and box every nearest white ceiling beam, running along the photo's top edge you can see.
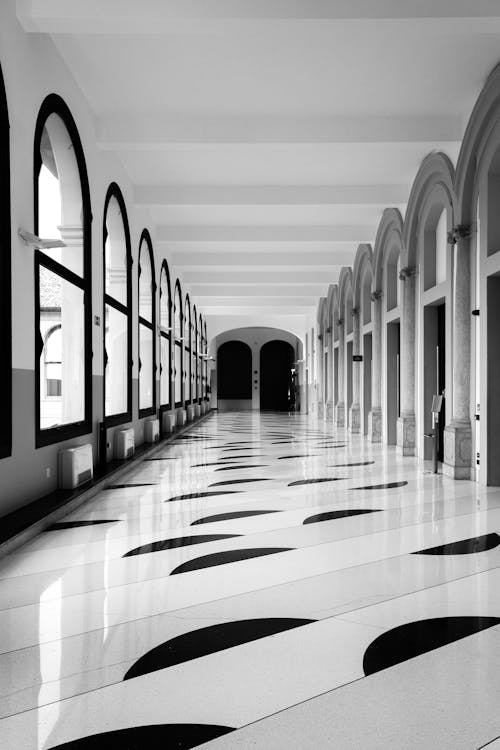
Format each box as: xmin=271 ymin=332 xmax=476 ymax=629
xmin=17 ymin=0 xmax=500 ymax=34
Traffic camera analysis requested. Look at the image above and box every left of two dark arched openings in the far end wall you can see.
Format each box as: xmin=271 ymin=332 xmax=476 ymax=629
xmin=217 ymin=341 xmax=252 ymax=411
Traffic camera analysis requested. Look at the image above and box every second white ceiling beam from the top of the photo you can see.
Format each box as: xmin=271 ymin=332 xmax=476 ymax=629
xmin=97 ymin=113 xmax=463 ymax=151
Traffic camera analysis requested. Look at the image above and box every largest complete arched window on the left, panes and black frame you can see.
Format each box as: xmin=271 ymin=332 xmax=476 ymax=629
xmin=34 ymin=94 xmax=92 ymax=447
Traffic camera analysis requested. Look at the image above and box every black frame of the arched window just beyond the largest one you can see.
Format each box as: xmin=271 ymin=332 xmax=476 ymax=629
xmin=102 ymin=182 xmax=133 ymax=427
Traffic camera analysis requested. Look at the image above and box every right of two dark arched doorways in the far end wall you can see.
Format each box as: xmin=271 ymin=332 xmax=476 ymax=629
xmin=260 ymin=341 xmax=295 ymax=411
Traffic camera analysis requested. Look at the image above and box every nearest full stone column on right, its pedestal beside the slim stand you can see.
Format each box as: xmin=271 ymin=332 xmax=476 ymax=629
xmin=443 ymin=226 xmax=472 ymax=479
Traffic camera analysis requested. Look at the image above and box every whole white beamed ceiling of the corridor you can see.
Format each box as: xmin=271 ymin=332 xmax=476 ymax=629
xmin=17 ymin=0 xmax=500 ymax=327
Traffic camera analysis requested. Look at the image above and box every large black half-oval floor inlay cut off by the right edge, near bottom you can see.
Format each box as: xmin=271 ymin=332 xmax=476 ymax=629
xmin=363 ymin=616 xmax=500 ymax=676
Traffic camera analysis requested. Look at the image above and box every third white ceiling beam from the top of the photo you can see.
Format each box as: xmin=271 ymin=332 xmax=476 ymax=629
xmin=134 ymin=185 xmax=408 ymax=208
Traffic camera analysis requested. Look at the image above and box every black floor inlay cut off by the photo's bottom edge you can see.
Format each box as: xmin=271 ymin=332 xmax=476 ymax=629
xmin=47 ymin=724 xmax=234 ymax=750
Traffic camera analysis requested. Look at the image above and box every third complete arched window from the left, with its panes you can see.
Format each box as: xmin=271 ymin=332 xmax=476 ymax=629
xmin=138 ymin=229 xmax=156 ymax=417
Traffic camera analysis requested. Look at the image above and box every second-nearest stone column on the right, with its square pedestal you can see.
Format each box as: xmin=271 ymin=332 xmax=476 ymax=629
xmin=397 ymin=268 xmax=416 ymax=456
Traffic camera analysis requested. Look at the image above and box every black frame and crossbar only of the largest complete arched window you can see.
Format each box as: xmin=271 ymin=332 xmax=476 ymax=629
xmin=33 ymin=94 xmax=92 ymax=448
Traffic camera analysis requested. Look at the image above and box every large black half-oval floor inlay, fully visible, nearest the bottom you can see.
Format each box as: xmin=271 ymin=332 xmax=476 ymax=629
xmin=123 ymin=617 xmax=315 ymax=680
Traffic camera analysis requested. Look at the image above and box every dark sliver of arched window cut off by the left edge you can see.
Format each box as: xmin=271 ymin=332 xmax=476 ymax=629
xmin=0 ymin=61 xmax=12 ymax=458
